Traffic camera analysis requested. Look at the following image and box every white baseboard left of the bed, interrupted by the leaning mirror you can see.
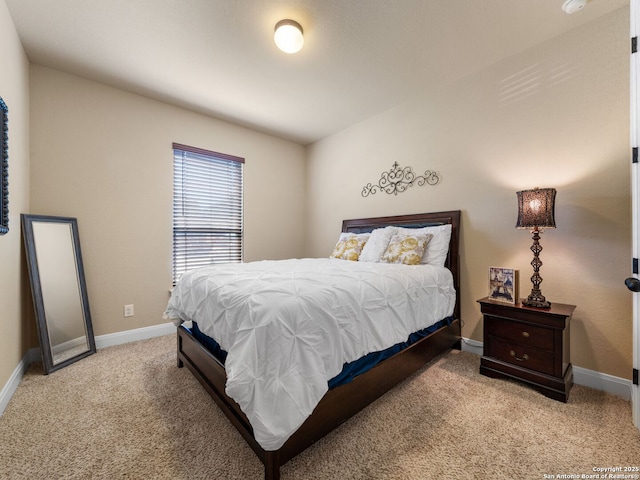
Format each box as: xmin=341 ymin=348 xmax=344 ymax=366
xmin=0 ymin=322 xmax=176 ymax=416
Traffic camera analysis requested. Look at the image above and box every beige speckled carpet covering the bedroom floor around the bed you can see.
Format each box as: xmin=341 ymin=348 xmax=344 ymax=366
xmin=0 ymin=335 xmax=640 ymax=480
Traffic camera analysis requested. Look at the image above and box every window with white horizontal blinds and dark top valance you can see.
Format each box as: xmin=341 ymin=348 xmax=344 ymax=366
xmin=173 ymin=143 xmax=244 ymax=285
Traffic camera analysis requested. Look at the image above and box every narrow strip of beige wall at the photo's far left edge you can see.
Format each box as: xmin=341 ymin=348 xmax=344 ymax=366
xmin=0 ymin=0 xmax=34 ymax=390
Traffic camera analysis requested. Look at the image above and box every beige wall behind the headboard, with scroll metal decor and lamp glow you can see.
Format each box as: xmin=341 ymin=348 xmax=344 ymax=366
xmin=307 ymin=8 xmax=632 ymax=378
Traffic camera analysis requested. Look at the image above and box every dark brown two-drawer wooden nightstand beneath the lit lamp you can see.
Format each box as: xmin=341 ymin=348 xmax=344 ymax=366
xmin=478 ymin=297 xmax=576 ymax=402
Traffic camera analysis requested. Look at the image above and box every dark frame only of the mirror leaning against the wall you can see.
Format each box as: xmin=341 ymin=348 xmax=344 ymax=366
xmin=20 ymin=214 xmax=96 ymax=375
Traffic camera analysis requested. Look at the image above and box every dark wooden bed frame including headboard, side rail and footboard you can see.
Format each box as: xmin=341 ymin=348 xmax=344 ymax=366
xmin=178 ymin=210 xmax=461 ymax=480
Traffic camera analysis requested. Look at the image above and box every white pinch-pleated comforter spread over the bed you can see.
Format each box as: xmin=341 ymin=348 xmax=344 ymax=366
xmin=165 ymin=259 xmax=456 ymax=450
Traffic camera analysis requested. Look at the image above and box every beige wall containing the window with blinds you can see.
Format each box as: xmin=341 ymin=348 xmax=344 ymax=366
xmin=31 ymin=65 xmax=305 ymax=335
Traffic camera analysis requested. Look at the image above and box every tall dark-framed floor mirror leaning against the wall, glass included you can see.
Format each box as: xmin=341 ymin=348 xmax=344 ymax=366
xmin=20 ymin=214 xmax=96 ymax=374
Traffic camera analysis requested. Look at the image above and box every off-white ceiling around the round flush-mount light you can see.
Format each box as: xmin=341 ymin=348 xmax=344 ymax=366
xmin=5 ymin=0 xmax=629 ymax=144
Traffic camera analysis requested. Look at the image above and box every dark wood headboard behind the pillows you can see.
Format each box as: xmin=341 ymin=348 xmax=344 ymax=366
xmin=342 ymin=210 xmax=460 ymax=318
